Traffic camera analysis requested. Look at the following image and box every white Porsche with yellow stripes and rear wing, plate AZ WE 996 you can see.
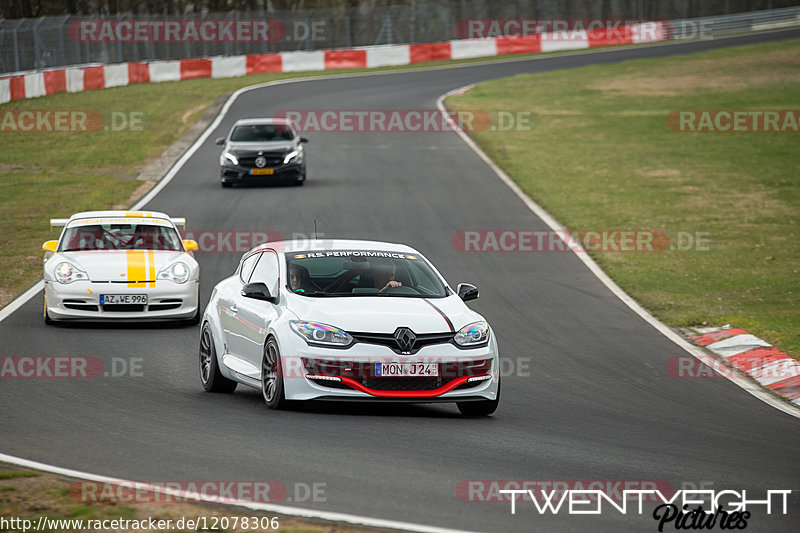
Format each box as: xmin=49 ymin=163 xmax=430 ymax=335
xmin=42 ymin=211 xmax=200 ymax=324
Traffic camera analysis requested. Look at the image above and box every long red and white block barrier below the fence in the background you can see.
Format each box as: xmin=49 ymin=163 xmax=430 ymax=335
xmin=0 ymin=22 xmax=669 ymax=104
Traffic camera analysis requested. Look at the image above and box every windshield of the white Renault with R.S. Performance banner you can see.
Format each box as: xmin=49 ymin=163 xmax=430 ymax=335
xmin=286 ymin=250 xmax=447 ymax=298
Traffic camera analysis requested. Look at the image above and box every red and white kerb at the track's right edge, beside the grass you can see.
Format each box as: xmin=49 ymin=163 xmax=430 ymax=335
xmin=689 ymin=326 xmax=800 ymax=406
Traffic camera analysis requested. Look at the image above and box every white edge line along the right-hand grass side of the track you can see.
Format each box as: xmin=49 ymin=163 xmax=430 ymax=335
xmin=436 ymin=85 xmax=800 ymax=418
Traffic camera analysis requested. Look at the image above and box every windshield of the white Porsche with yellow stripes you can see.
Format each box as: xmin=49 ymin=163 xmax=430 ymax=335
xmin=59 ymin=223 xmax=183 ymax=252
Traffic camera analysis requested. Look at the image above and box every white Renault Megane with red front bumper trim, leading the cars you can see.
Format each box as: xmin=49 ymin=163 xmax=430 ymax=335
xmin=200 ymin=240 xmax=500 ymax=416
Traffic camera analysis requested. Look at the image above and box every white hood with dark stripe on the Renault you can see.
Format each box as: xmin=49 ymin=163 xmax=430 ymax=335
xmin=287 ymin=293 xmax=483 ymax=333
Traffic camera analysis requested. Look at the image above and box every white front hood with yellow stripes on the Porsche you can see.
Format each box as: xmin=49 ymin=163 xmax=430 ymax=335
xmin=53 ymin=250 xmax=188 ymax=281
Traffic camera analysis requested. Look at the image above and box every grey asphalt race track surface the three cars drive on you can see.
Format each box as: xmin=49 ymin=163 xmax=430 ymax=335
xmin=0 ymin=30 xmax=800 ymax=532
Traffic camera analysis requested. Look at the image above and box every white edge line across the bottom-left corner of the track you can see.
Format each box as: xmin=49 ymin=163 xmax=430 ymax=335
xmin=0 ymin=453 xmax=476 ymax=533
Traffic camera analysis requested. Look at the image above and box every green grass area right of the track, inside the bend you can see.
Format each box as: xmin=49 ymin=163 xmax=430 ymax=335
xmin=446 ymin=40 xmax=800 ymax=357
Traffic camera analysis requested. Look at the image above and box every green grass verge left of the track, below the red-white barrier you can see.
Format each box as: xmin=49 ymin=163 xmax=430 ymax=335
xmin=0 ymin=45 xmax=624 ymax=307
